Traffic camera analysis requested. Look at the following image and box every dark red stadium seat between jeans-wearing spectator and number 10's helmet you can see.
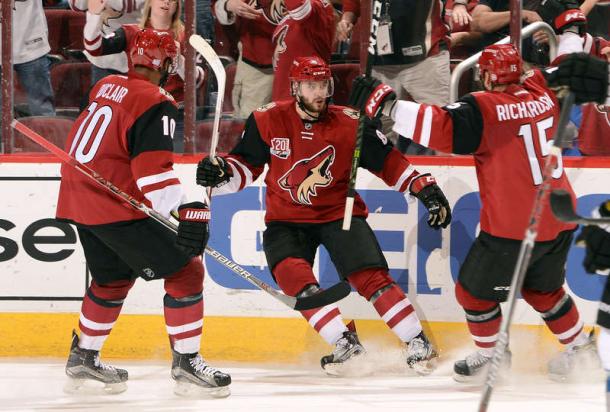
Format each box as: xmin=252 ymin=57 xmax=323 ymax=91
xmin=51 ymin=62 xmax=91 ymax=108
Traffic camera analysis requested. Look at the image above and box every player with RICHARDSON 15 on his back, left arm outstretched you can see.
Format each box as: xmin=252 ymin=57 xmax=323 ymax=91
xmin=351 ymin=37 xmax=608 ymax=381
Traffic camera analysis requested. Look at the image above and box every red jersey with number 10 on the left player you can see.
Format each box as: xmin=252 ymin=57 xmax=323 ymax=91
xmin=57 ymin=73 xmax=183 ymax=225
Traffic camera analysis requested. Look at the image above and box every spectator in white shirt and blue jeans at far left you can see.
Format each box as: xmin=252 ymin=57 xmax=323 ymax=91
xmin=0 ymin=0 xmax=55 ymax=116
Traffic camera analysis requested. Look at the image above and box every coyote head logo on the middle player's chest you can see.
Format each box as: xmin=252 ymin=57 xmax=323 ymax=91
xmin=278 ymin=146 xmax=335 ymax=205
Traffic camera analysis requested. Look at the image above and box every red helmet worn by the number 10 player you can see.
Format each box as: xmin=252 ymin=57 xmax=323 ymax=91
xmin=129 ymin=29 xmax=178 ymax=73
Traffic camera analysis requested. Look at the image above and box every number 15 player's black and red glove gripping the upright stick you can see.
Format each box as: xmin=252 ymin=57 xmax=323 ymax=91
xmin=348 ymin=76 xmax=396 ymax=119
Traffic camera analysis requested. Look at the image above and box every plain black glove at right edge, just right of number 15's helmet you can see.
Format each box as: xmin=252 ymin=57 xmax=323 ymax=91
xmin=546 ymin=53 xmax=610 ymax=104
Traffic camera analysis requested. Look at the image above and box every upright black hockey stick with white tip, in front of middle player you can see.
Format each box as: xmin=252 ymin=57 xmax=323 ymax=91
xmin=342 ymin=0 xmax=383 ymax=230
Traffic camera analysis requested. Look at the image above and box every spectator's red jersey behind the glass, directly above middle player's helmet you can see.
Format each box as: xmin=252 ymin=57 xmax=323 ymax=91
xmin=272 ymin=0 xmax=335 ymax=101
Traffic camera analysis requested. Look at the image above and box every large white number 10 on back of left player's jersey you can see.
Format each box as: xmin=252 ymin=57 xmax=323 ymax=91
xmin=70 ymin=102 xmax=112 ymax=164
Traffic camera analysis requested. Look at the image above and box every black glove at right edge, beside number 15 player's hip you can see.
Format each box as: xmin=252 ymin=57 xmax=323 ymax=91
xmin=576 ymin=201 xmax=610 ymax=273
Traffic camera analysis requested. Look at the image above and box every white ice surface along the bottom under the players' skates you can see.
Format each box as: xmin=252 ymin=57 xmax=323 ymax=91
xmin=0 ymin=360 xmax=605 ymax=412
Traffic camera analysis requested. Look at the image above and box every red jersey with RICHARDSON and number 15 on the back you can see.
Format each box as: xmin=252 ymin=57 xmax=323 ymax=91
xmin=392 ymin=71 xmax=575 ymax=241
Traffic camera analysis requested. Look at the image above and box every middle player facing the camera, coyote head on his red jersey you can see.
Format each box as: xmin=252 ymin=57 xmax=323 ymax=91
xmin=197 ymin=57 xmax=451 ymax=374
